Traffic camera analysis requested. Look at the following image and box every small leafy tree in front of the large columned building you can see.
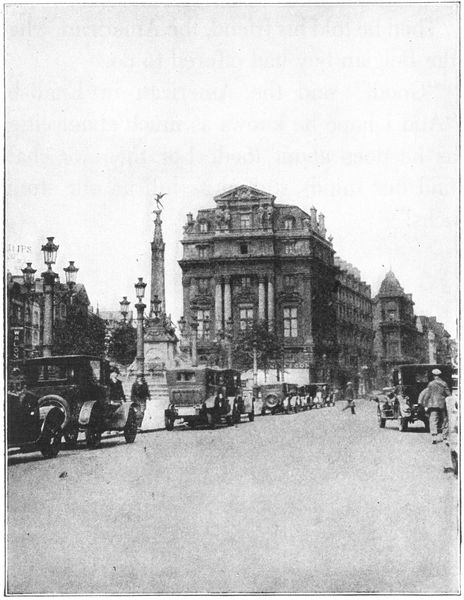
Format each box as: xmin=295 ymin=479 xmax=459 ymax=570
xmin=232 ymin=321 xmax=283 ymax=372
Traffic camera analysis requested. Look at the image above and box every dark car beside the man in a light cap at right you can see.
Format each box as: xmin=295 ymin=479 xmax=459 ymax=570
xmin=392 ymin=364 xmax=453 ymax=432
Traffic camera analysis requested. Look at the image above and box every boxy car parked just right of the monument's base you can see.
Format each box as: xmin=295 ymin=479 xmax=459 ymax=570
xmin=164 ymin=366 xmax=243 ymax=431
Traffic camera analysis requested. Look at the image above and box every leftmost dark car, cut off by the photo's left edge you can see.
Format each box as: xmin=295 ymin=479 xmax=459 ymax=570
xmin=6 ymin=388 xmax=64 ymax=458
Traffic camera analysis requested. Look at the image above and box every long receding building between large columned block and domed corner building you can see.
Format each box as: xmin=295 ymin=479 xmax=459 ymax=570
xmin=335 ymin=256 xmax=374 ymax=393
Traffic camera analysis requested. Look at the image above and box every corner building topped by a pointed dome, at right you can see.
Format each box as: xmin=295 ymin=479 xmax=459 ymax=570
xmin=374 ymin=271 xmax=423 ymax=385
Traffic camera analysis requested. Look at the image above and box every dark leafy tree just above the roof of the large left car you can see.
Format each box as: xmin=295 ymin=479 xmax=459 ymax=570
xmin=53 ymin=305 xmax=105 ymax=356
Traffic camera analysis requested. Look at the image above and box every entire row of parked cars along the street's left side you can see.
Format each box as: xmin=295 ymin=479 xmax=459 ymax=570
xmin=7 ymin=355 xmax=335 ymax=457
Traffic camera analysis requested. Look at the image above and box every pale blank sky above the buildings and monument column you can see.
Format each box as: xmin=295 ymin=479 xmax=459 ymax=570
xmin=5 ymin=3 xmax=459 ymax=336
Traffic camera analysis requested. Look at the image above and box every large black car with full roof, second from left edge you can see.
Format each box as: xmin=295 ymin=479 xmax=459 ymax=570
xmin=19 ymin=355 xmax=137 ymax=448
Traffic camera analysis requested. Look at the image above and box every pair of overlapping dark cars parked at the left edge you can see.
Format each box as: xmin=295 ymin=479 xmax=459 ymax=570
xmin=7 ymin=355 xmax=140 ymax=458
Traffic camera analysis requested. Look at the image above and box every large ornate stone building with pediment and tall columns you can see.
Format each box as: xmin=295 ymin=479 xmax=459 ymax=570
xmin=179 ymin=185 xmax=338 ymax=381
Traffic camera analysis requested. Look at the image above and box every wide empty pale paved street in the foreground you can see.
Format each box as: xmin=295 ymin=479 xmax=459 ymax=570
xmin=8 ymin=401 xmax=459 ymax=593
